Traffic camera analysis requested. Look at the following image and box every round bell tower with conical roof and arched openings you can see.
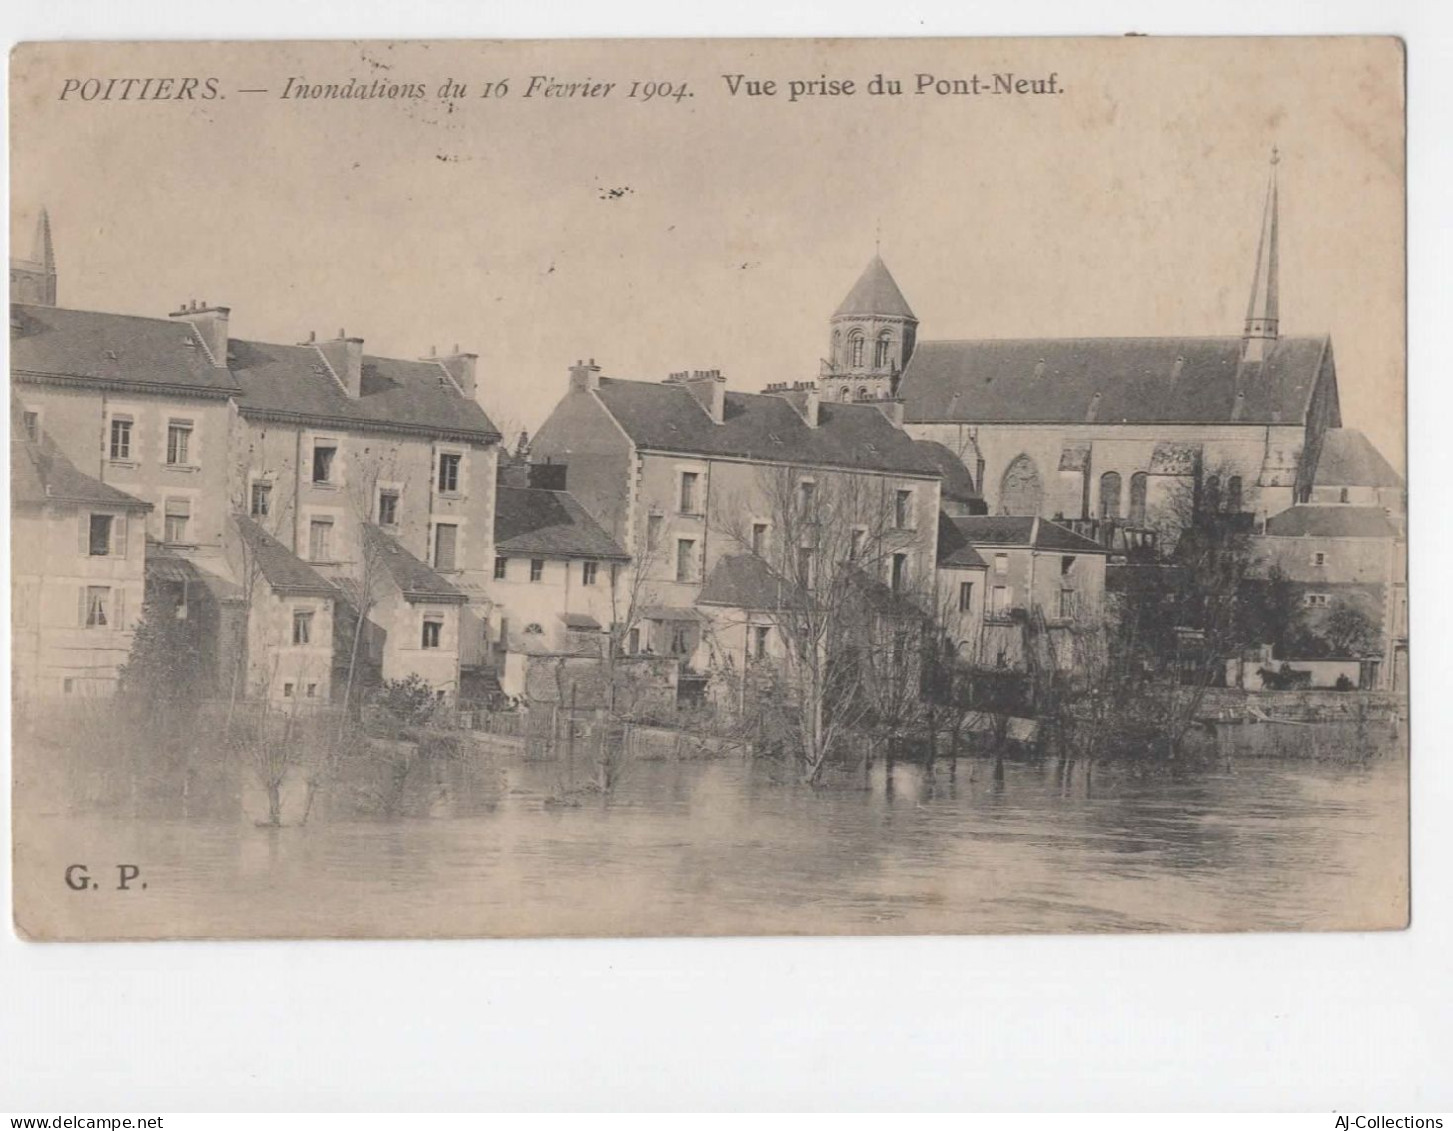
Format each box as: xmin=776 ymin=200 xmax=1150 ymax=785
xmin=818 ymin=254 xmax=918 ymax=401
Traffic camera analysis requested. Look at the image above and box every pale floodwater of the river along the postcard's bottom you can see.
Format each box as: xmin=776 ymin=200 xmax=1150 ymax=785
xmin=17 ymin=757 xmax=1407 ymax=938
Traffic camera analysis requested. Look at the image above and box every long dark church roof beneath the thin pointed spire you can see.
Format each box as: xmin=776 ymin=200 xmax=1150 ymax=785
xmin=898 ymin=337 xmax=1331 ymax=424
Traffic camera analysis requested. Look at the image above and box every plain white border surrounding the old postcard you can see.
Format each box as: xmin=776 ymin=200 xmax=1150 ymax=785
xmin=0 ymin=0 xmax=1453 ymax=1110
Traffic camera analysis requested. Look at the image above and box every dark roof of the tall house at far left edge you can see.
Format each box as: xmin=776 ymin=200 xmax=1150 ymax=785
xmin=10 ymin=302 xmax=238 ymax=395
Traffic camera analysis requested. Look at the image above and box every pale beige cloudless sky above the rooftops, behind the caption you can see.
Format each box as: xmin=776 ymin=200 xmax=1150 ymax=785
xmin=12 ymin=38 xmax=1405 ymax=468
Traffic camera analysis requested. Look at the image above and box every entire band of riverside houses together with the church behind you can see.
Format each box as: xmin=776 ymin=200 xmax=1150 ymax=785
xmin=10 ymin=154 xmax=1407 ymax=702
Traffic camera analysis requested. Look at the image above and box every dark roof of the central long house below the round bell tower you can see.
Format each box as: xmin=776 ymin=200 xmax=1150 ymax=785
xmin=599 ymin=378 xmax=939 ymax=477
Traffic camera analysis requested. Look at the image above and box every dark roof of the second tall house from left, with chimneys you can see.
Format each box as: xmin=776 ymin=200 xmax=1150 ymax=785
xmin=228 ymin=339 xmax=500 ymax=440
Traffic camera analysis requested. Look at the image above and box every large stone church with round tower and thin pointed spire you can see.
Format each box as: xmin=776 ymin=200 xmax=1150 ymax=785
xmin=818 ymin=153 xmax=1360 ymax=532
